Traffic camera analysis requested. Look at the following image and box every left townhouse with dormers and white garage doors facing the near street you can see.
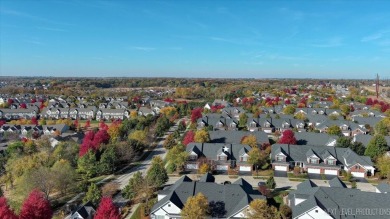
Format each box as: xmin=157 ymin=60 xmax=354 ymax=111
xmin=186 ymin=143 xmax=252 ymax=172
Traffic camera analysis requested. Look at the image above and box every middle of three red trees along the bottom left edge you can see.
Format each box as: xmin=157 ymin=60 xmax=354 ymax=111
xmin=19 ymin=190 xmax=53 ymax=219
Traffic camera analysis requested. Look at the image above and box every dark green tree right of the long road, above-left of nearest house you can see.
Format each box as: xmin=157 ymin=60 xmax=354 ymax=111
xmin=146 ymin=156 xmax=169 ymax=187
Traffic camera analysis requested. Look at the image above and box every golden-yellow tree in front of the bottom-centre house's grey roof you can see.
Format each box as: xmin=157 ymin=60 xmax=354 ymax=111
xmin=180 ymin=193 xmax=209 ymax=219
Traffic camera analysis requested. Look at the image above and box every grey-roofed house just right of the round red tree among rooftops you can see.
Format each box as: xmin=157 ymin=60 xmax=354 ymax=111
xmin=294 ymin=132 xmax=339 ymax=146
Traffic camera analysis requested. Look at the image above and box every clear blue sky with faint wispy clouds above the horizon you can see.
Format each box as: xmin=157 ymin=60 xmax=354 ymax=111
xmin=0 ymin=0 xmax=390 ymax=78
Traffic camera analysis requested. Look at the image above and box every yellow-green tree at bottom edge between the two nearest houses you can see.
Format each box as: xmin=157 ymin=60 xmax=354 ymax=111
xmin=247 ymin=199 xmax=277 ymax=219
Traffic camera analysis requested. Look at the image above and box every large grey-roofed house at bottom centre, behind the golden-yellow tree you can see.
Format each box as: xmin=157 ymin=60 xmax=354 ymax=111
xmin=150 ymin=174 xmax=266 ymax=219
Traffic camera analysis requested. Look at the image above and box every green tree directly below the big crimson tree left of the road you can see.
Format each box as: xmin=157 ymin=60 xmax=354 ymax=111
xmin=77 ymin=150 xmax=97 ymax=179
